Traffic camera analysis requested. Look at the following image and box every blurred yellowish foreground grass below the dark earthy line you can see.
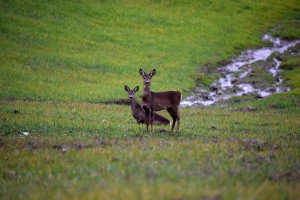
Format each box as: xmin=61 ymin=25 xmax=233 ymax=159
xmin=1 ymin=137 xmax=299 ymax=199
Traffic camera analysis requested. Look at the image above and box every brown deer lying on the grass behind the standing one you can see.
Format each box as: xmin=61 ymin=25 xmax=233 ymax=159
xmin=125 ymin=85 xmax=170 ymax=126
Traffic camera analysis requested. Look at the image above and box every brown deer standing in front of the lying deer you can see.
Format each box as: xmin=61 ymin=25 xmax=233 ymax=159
xmin=139 ymin=69 xmax=181 ymax=132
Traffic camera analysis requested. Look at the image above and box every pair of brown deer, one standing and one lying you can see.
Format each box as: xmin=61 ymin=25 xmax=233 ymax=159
xmin=125 ymin=69 xmax=181 ymax=132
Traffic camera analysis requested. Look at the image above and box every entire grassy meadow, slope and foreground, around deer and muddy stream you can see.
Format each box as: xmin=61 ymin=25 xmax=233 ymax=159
xmin=0 ymin=0 xmax=300 ymax=200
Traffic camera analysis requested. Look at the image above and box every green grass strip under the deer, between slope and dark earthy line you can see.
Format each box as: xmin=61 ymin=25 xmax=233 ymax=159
xmin=1 ymin=100 xmax=299 ymax=139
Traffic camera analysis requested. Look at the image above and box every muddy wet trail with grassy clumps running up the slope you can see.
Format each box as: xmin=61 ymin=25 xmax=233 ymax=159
xmin=181 ymin=35 xmax=300 ymax=107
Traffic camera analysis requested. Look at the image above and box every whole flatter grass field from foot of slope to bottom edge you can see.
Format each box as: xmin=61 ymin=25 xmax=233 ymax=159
xmin=0 ymin=98 xmax=300 ymax=199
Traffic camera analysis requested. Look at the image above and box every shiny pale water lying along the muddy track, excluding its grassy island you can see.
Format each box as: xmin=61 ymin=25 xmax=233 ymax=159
xmin=181 ymin=35 xmax=300 ymax=107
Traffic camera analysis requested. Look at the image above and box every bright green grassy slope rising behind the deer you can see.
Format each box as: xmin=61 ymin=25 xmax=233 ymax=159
xmin=0 ymin=0 xmax=300 ymax=102
